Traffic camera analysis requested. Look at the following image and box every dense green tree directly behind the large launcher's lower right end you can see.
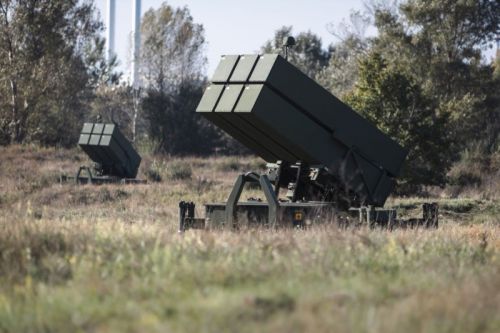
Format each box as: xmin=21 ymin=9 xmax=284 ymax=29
xmin=345 ymin=53 xmax=450 ymax=185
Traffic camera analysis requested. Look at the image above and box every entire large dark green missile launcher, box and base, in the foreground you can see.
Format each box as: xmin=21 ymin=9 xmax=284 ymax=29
xmin=180 ymin=54 xmax=438 ymax=231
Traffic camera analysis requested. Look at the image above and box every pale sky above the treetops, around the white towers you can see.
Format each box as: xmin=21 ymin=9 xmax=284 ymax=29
xmin=96 ymin=0 xmax=363 ymax=75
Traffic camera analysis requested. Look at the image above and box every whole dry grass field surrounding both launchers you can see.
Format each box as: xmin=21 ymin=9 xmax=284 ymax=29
xmin=0 ymin=146 xmax=500 ymax=332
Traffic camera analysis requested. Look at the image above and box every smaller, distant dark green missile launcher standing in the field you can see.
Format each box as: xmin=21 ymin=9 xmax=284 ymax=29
xmin=61 ymin=123 xmax=146 ymax=184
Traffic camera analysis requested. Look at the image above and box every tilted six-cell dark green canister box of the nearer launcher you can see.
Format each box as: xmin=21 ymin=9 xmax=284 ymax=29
xmin=196 ymin=54 xmax=407 ymax=206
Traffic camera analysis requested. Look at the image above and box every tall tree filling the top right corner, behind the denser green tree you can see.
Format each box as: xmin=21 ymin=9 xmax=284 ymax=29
xmin=373 ymin=0 xmax=500 ymax=156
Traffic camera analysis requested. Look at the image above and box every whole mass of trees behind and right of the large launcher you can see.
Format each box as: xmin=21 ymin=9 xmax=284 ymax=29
xmin=263 ymin=0 xmax=500 ymax=185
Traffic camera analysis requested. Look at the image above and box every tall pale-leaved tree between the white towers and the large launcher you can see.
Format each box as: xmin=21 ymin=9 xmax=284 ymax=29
xmin=141 ymin=3 xmax=220 ymax=154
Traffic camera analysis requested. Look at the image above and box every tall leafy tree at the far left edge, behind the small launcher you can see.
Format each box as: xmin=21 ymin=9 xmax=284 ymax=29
xmin=0 ymin=0 xmax=107 ymax=145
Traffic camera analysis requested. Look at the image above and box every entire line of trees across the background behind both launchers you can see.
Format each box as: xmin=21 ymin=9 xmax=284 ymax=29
xmin=0 ymin=0 xmax=500 ymax=186
